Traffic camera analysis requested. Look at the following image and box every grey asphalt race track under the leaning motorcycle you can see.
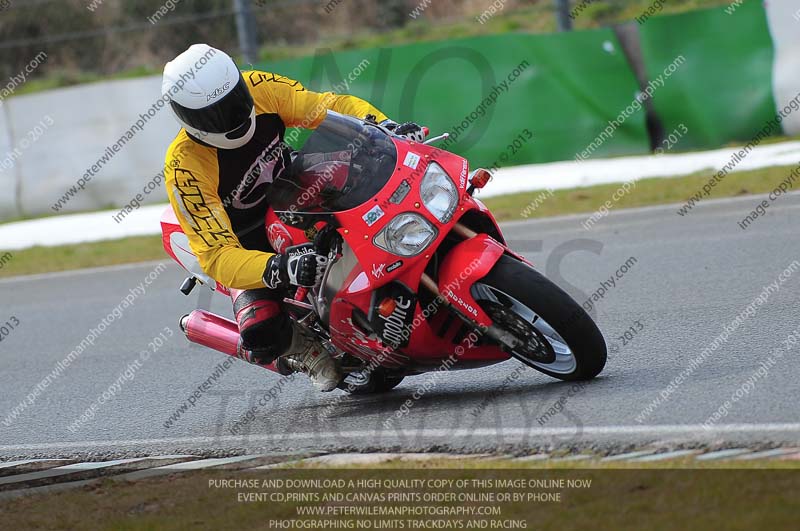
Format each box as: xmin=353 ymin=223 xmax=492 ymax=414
xmin=0 ymin=194 xmax=800 ymax=459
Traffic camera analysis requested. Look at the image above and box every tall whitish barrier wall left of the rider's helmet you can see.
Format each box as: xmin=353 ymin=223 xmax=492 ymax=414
xmin=0 ymin=76 xmax=179 ymax=221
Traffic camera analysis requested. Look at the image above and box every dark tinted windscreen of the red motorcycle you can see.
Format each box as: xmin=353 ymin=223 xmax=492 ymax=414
xmin=269 ymin=111 xmax=397 ymax=212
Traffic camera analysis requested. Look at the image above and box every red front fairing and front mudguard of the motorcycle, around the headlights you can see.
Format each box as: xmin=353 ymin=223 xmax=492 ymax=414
xmin=320 ymin=140 xmax=509 ymax=368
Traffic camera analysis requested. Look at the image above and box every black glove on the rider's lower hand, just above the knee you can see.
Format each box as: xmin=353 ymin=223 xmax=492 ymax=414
xmin=264 ymin=243 xmax=328 ymax=289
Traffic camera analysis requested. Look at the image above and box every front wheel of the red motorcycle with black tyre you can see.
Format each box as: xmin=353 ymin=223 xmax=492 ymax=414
xmin=472 ymin=255 xmax=607 ymax=381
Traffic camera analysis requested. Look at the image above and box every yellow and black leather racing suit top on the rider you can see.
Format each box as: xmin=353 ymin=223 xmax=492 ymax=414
xmin=164 ymin=70 xmax=386 ymax=290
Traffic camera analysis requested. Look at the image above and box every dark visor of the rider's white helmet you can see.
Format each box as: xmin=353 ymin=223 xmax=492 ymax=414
xmin=170 ymin=72 xmax=253 ymax=133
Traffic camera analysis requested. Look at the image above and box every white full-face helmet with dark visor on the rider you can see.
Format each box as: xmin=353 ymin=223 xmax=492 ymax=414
xmin=161 ymin=44 xmax=256 ymax=149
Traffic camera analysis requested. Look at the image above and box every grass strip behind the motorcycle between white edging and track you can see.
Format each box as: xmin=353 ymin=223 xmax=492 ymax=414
xmin=0 ymin=166 xmax=794 ymax=277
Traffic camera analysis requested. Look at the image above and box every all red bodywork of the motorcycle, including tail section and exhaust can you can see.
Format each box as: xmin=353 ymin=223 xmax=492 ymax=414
xmin=162 ymin=114 xmax=516 ymax=372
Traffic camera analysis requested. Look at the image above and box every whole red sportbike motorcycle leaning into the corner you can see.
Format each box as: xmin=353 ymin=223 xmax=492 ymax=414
xmin=162 ymin=111 xmax=606 ymax=393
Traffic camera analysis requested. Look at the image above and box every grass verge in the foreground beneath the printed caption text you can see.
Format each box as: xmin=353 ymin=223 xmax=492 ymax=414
xmin=0 ymin=460 xmax=800 ymax=530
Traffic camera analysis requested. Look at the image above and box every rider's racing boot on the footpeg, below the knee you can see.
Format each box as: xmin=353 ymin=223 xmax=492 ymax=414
xmin=278 ymin=323 xmax=343 ymax=393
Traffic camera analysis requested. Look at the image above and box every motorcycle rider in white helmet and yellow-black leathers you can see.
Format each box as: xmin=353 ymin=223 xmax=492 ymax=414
xmin=162 ymin=44 xmax=424 ymax=391
